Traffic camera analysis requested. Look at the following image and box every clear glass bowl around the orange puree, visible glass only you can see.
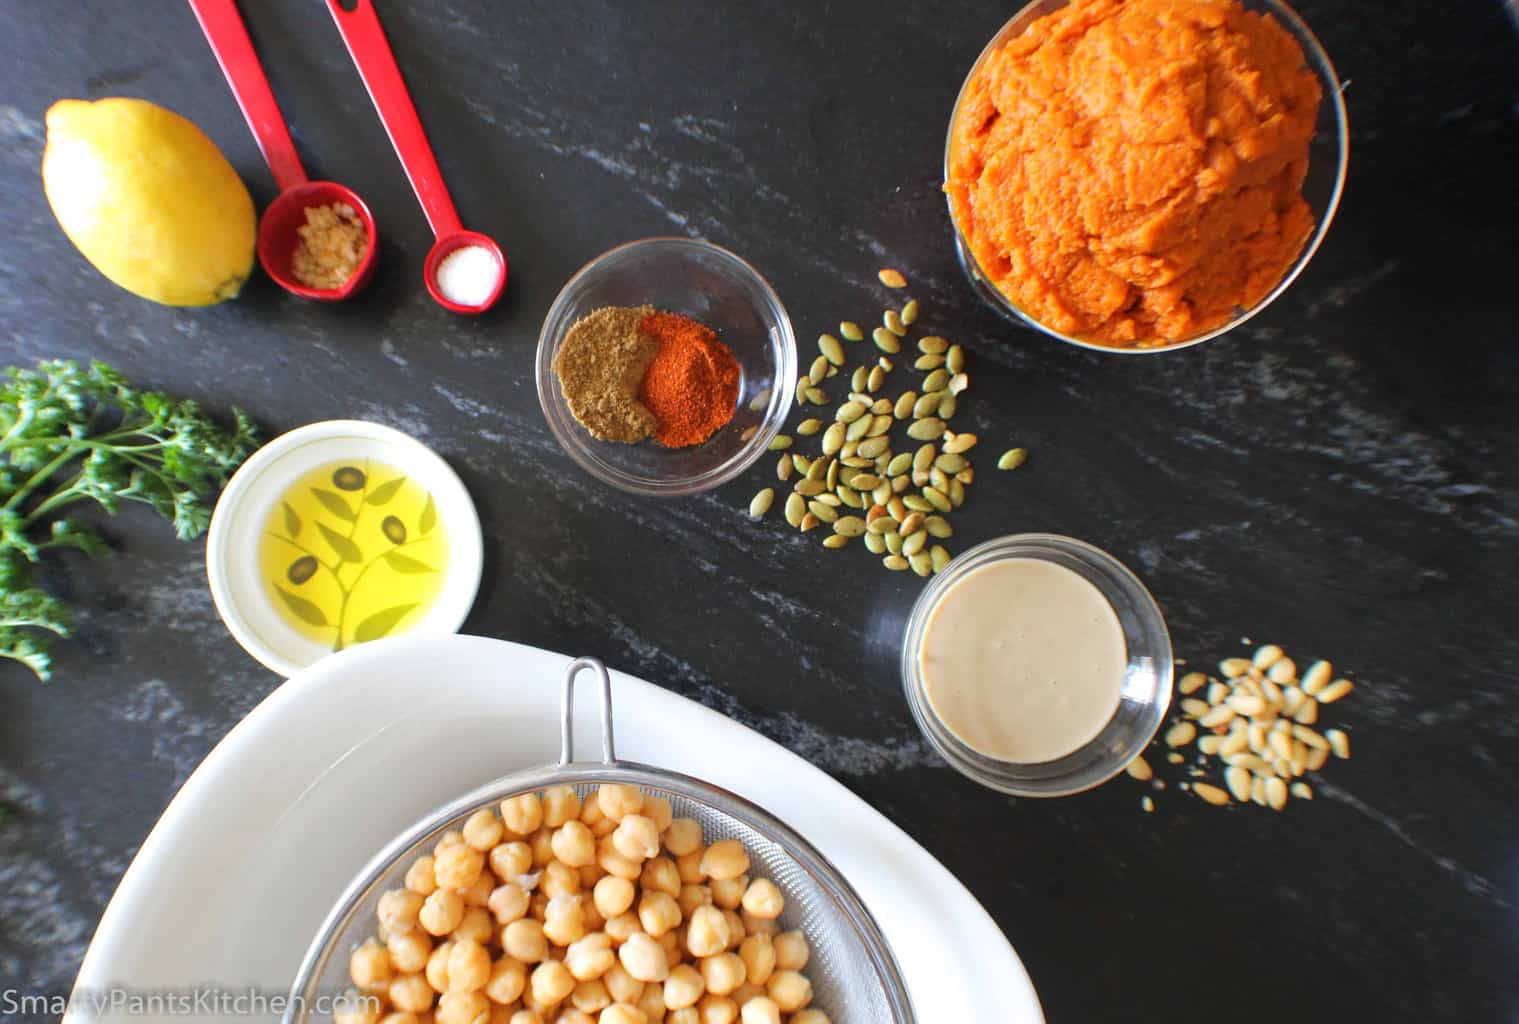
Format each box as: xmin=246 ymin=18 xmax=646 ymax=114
xmin=945 ymin=0 xmax=1350 ymax=356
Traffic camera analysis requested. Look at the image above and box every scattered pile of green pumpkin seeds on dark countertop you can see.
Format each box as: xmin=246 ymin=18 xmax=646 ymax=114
xmin=749 ymin=267 xmax=1027 ymax=576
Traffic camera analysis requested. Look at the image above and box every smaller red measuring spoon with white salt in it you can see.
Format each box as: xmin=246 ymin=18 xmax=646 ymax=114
xmin=327 ymin=0 xmax=506 ymax=313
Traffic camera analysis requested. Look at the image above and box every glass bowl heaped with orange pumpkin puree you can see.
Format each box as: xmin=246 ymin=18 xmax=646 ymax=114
xmin=945 ymin=0 xmax=1349 ymax=352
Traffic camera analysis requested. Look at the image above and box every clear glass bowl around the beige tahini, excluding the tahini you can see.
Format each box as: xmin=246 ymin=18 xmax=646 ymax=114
xmin=902 ymin=533 xmax=1173 ymax=796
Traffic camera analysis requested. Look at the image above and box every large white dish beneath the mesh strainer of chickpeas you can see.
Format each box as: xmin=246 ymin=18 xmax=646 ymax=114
xmin=74 ymin=637 xmax=1044 ymax=1024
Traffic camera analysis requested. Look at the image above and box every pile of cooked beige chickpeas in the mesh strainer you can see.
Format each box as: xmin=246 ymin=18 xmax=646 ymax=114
xmin=334 ymin=784 xmax=829 ymax=1024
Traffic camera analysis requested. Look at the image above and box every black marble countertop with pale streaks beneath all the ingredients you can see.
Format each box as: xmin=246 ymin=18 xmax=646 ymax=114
xmin=0 ymin=0 xmax=1519 ymax=1024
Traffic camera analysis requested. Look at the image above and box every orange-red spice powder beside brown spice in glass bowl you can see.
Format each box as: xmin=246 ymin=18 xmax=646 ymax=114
xmin=638 ymin=313 xmax=738 ymax=448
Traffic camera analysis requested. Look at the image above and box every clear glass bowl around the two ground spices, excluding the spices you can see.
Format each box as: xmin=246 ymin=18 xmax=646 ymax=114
xmin=538 ymin=239 xmax=797 ymax=497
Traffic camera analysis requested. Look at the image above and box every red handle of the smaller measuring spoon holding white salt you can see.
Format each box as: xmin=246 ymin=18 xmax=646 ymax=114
xmin=327 ymin=0 xmax=463 ymax=237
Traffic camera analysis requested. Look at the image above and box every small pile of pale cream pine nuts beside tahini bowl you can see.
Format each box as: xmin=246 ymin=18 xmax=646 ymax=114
xmin=1129 ymin=644 xmax=1355 ymax=811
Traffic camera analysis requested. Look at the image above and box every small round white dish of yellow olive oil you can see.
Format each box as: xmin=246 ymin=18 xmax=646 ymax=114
xmin=207 ymin=419 xmax=482 ymax=676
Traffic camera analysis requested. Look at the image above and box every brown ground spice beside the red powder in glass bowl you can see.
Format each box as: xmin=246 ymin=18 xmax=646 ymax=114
xmin=553 ymin=305 xmax=659 ymax=444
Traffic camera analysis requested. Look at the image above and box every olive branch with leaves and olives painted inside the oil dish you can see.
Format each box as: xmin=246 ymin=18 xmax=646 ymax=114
xmin=269 ymin=463 xmax=437 ymax=650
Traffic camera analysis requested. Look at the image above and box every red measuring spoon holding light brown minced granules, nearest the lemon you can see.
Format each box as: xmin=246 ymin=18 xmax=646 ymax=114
xmin=190 ymin=0 xmax=380 ymax=302
